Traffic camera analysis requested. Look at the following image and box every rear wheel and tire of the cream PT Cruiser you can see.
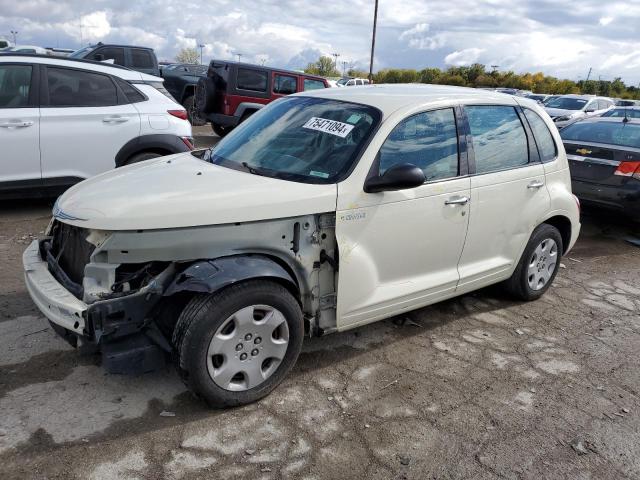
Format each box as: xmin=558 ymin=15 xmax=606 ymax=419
xmin=504 ymin=223 xmax=564 ymax=301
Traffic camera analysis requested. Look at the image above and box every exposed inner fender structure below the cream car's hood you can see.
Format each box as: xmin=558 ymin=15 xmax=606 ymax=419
xmin=83 ymin=213 xmax=338 ymax=333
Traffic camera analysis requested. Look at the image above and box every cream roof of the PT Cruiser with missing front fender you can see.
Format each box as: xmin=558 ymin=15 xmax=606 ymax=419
xmin=295 ymin=83 xmax=524 ymax=115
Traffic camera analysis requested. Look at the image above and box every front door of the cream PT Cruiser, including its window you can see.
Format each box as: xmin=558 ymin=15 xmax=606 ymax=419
xmin=336 ymin=108 xmax=470 ymax=329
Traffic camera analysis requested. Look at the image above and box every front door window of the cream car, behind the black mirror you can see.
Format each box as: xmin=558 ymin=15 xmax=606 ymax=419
xmin=379 ymin=108 xmax=458 ymax=181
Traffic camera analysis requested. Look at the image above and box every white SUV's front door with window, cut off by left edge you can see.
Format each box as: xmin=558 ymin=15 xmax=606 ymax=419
xmin=0 ymin=63 xmax=41 ymax=184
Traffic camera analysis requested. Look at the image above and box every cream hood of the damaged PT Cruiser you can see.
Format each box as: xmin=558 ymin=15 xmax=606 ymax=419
xmin=53 ymin=153 xmax=337 ymax=230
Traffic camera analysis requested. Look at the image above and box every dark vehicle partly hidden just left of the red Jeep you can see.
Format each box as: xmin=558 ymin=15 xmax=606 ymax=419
xmin=160 ymin=63 xmax=208 ymax=126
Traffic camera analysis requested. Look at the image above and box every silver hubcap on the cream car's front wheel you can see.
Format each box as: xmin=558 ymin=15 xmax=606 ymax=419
xmin=207 ymin=305 xmax=289 ymax=392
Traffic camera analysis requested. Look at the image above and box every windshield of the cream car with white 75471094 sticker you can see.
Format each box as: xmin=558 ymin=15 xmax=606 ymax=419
xmin=210 ymin=97 xmax=380 ymax=184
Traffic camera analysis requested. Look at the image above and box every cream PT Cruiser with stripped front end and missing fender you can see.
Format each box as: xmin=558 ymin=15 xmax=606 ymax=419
xmin=24 ymin=85 xmax=580 ymax=406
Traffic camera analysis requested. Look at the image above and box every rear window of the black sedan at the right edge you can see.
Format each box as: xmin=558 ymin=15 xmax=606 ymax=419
xmin=560 ymin=121 xmax=640 ymax=148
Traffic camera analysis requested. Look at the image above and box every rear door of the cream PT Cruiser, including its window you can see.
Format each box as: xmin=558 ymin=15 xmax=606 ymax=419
xmin=458 ymin=105 xmax=550 ymax=292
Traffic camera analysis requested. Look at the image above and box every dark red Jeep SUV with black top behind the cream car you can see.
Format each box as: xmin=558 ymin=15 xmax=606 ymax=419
xmin=196 ymin=60 xmax=329 ymax=137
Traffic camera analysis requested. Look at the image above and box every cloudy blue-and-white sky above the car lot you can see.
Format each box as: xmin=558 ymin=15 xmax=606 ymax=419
xmin=0 ymin=0 xmax=640 ymax=85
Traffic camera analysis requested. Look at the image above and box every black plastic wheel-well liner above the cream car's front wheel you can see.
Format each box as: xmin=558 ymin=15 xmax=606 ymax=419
xmin=163 ymin=255 xmax=298 ymax=297
